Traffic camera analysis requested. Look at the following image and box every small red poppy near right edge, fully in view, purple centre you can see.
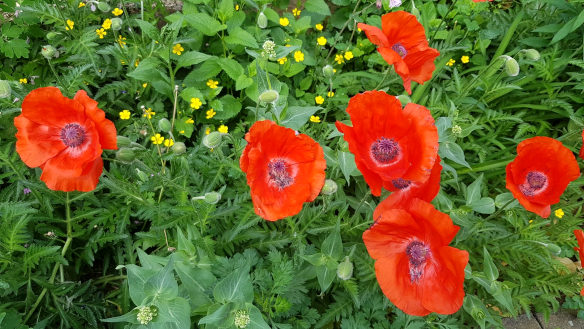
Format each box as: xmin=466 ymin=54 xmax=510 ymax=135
xmin=507 ymin=137 xmax=580 ymax=218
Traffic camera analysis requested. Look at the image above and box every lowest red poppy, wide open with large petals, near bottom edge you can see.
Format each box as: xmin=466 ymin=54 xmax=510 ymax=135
xmin=363 ymin=199 xmax=468 ymax=316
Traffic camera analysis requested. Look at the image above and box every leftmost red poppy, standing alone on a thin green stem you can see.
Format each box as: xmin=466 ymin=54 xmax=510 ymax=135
xmin=14 ymin=87 xmax=118 ymax=192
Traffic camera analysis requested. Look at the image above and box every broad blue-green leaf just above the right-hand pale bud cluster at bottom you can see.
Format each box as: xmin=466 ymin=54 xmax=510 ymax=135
xmin=213 ymin=268 xmax=253 ymax=303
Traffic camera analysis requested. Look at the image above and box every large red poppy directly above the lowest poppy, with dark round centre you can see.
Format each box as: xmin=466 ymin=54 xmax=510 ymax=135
xmin=336 ymin=91 xmax=438 ymax=196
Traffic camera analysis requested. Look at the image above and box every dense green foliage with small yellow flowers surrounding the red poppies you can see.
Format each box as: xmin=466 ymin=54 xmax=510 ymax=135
xmin=0 ymin=0 xmax=584 ymax=329
